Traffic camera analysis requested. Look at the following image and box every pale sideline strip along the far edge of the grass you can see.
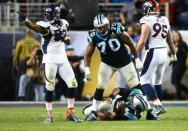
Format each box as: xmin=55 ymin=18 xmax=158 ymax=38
xmin=0 ymin=101 xmax=188 ymax=108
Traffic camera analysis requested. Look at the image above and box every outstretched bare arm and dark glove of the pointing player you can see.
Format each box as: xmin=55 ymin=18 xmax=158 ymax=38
xmin=17 ymin=12 xmax=48 ymax=35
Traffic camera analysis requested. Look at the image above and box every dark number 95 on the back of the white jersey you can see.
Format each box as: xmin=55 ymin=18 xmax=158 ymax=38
xmin=152 ymin=23 xmax=168 ymax=39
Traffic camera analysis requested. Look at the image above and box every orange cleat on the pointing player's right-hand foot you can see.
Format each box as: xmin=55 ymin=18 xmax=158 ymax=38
xmin=66 ymin=109 xmax=83 ymax=123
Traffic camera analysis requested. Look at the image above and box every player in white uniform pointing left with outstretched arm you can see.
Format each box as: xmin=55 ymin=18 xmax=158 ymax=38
xmin=18 ymin=4 xmax=81 ymax=123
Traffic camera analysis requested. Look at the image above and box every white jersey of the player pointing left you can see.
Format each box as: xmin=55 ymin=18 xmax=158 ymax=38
xmin=36 ymin=19 xmax=69 ymax=64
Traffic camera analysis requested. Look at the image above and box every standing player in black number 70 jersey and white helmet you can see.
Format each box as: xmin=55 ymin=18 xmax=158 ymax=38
xmin=84 ymin=14 xmax=158 ymax=121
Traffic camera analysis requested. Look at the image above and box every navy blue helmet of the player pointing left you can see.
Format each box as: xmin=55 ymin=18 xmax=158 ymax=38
xmin=45 ymin=4 xmax=60 ymax=23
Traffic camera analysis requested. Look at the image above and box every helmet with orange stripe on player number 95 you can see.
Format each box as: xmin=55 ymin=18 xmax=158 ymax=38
xmin=143 ymin=0 xmax=160 ymax=16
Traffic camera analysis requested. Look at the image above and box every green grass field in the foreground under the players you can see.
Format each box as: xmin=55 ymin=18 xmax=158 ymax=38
xmin=0 ymin=107 xmax=188 ymax=131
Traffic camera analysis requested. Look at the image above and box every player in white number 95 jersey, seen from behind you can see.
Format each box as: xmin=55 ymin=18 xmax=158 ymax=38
xmin=137 ymin=0 xmax=177 ymax=115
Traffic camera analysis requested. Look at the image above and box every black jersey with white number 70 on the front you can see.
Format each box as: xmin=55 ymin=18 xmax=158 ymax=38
xmin=88 ymin=23 xmax=131 ymax=68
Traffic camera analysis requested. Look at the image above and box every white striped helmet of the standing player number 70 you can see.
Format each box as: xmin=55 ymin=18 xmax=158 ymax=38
xmin=93 ymin=14 xmax=109 ymax=28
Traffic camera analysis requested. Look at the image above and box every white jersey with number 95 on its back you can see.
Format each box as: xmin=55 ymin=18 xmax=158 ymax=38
xmin=140 ymin=15 xmax=170 ymax=49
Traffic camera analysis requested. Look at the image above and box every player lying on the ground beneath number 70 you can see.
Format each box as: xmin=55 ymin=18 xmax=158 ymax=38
xmin=83 ymin=88 xmax=150 ymax=120
